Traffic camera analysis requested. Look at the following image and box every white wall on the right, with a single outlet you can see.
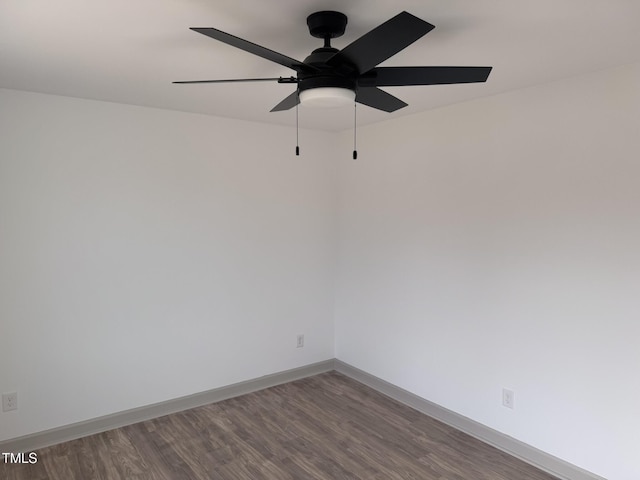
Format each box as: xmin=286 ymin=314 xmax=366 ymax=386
xmin=336 ymin=64 xmax=640 ymax=480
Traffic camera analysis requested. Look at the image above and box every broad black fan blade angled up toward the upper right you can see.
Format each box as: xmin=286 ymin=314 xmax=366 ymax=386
xmin=327 ymin=12 xmax=435 ymax=73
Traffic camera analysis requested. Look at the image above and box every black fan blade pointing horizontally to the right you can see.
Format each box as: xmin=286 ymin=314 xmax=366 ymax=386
xmin=358 ymin=67 xmax=492 ymax=87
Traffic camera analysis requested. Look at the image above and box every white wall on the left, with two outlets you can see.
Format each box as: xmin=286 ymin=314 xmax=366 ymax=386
xmin=0 ymin=90 xmax=336 ymax=440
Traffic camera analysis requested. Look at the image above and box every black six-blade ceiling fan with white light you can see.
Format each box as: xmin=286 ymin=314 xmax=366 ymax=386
xmin=173 ymin=11 xmax=492 ymax=112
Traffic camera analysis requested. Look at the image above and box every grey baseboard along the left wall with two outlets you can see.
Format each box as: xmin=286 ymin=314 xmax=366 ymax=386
xmin=0 ymin=359 xmax=334 ymax=453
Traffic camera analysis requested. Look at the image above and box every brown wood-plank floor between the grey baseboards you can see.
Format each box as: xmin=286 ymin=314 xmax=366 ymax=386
xmin=0 ymin=372 xmax=554 ymax=480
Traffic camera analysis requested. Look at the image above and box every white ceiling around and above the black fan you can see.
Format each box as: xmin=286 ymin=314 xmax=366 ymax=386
xmin=0 ymin=0 xmax=640 ymax=130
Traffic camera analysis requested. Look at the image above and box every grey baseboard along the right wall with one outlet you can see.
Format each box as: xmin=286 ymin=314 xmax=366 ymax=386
xmin=334 ymin=359 xmax=606 ymax=480
